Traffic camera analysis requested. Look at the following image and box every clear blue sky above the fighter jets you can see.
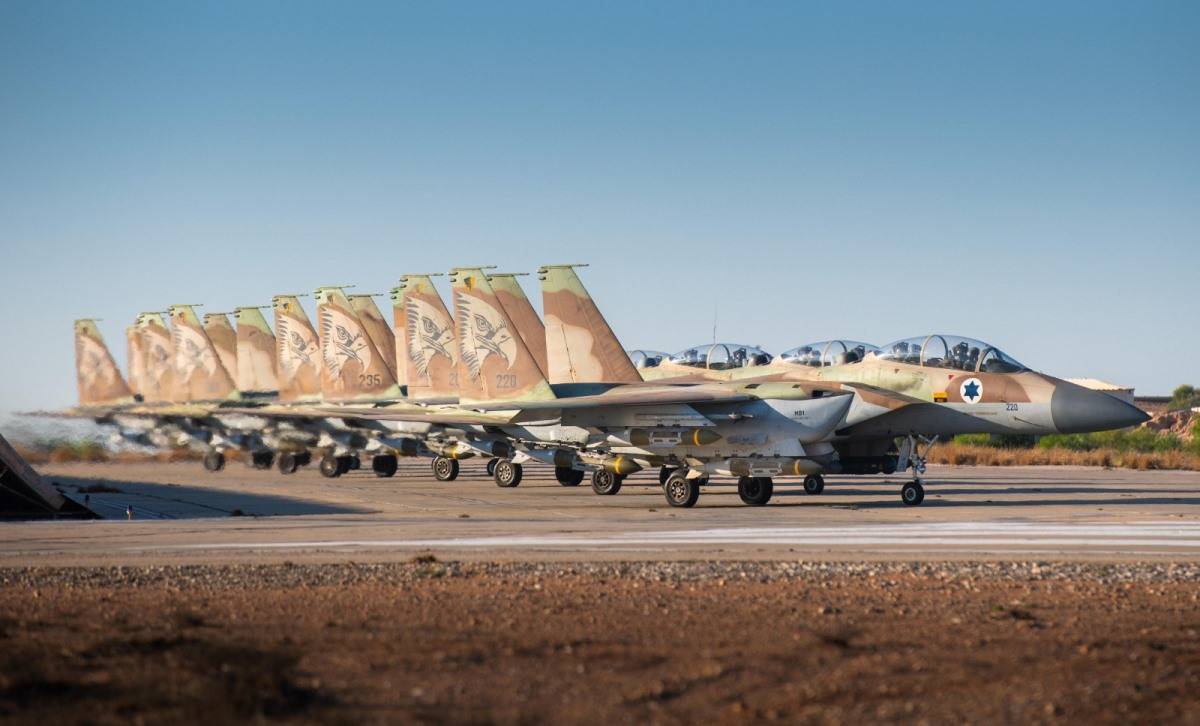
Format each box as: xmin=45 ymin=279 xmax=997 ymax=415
xmin=0 ymin=0 xmax=1200 ymax=410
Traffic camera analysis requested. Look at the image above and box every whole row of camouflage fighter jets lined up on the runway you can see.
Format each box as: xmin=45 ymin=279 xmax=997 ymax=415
xmin=68 ymin=265 xmax=1146 ymax=506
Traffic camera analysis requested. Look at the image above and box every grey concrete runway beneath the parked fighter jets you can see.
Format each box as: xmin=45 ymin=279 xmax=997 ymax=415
xmin=9 ymin=460 xmax=1200 ymax=565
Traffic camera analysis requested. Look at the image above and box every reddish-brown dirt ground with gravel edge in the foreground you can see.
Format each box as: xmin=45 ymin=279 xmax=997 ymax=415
xmin=0 ymin=558 xmax=1200 ymax=724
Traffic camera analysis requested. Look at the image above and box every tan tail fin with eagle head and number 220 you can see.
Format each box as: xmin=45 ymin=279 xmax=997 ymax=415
xmin=450 ymin=268 xmax=554 ymax=403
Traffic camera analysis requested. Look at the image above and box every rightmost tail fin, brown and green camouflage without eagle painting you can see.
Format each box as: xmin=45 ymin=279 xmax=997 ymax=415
xmin=538 ymin=265 xmax=642 ymax=383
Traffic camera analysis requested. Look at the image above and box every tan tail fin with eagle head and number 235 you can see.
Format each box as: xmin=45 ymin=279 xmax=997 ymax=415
xmin=314 ymin=287 xmax=400 ymax=401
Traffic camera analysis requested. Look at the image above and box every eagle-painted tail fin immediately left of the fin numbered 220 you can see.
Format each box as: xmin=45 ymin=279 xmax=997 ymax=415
xmin=394 ymin=275 xmax=458 ymax=401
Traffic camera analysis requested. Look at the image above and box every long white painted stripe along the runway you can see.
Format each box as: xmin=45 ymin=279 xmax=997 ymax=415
xmin=154 ymin=522 xmax=1200 ymax=552
